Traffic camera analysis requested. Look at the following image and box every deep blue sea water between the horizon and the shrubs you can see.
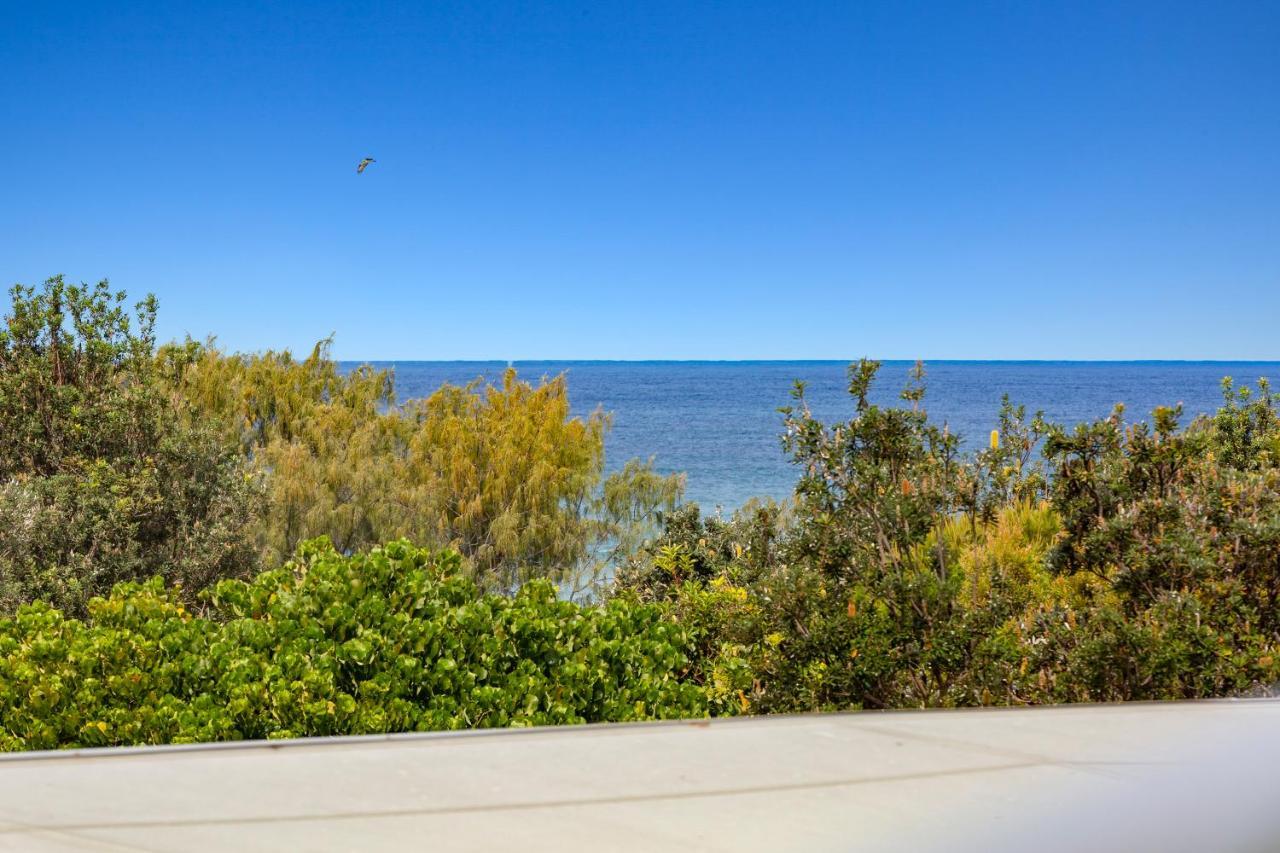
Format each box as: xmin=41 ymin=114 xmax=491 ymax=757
xmin=343 ymin=361 xmax=1280 ymax=511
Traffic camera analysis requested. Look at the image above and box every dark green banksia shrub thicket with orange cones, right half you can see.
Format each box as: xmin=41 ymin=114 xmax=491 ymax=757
xmin=614 ymin=361 xmax=1280 ymax=713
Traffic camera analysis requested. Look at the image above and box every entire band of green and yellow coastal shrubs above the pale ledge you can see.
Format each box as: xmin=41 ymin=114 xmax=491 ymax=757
xmin=0 ymin=279 xmax=1280 ymax=749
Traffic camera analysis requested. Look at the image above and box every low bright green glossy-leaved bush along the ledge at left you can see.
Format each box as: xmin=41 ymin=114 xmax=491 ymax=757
xmin=0 ymin=542 xmax=707 ymax=749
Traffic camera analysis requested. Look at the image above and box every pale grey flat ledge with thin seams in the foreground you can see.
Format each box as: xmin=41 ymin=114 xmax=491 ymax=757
xmin=0 ymin=699 xmax=1280 ymax=853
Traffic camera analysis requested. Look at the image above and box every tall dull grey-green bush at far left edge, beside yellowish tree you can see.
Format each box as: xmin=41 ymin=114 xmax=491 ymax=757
xmin=0 ymin=278 xmax=259 ymax=613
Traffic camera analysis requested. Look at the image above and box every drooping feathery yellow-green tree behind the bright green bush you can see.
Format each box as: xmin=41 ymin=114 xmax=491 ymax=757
xmin=177 ymin=341 xmax=682 ymax=589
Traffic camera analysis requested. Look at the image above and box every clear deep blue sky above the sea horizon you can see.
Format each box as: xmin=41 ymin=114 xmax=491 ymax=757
xmin=0 ymin=0 xmax=1280 ymax=359
